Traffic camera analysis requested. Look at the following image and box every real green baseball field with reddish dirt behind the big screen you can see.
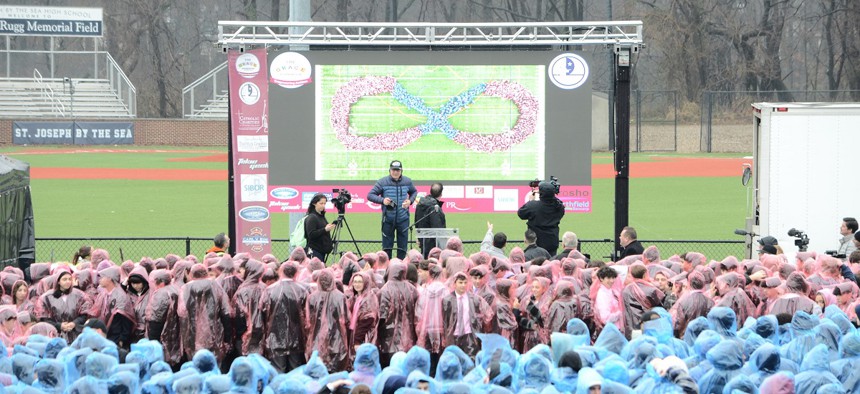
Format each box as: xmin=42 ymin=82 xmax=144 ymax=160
xmin=0 ymin=147 xmax=747 ymax=257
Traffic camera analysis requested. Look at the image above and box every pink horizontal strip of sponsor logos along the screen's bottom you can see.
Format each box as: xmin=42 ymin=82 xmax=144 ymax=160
xmin=268 ymin=185 xmax=591 ymax=213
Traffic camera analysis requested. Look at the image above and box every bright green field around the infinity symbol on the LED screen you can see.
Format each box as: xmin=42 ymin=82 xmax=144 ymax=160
xmin=316 ymin=65 xmax=544 ymax=181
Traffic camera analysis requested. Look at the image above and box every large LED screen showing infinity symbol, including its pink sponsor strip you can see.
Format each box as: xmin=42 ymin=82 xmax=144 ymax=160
xmin=268 ymin=51 xmax=591 ymax=212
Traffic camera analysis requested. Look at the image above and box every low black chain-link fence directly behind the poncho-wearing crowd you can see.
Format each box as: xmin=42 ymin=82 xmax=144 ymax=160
xmin=36 ymin=237 xmax=744 ymax=262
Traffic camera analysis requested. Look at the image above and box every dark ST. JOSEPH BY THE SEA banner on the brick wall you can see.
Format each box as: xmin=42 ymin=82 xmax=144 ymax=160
xmin=12 ymin=122 xmax=134 ymax=145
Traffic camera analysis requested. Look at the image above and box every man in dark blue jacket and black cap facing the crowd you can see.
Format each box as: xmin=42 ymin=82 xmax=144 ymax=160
xmin=367 ymin=160 xmax=418 ymax=260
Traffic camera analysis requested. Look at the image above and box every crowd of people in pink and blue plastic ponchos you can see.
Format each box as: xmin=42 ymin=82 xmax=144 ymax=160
xmin=0 ymin=238 xmax=860 ymax=394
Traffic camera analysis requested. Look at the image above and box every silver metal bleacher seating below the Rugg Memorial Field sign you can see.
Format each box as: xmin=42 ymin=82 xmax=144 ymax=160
xmin=0 ymin=78 xmax=135 ymax=118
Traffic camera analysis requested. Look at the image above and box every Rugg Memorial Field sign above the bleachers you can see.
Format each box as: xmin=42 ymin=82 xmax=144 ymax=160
xmin=0 ymin=6 xmax=104 ymax=37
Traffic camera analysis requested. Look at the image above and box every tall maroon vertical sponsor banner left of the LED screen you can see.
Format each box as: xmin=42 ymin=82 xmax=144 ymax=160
xmin=227 ymin=48 xmax=272 ymax=259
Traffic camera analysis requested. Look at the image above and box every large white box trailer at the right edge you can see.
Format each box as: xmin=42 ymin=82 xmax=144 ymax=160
xmin=746 ymin=103 xmax=860 ymax=258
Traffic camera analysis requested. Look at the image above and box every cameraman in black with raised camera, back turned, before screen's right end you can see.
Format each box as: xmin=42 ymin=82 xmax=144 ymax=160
xmin=517 ymin=181 xmax=564 ymax=256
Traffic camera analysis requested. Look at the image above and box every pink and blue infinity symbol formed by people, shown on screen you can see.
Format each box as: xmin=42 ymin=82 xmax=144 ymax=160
xmin=331 ymin=76 xmax=540 ymax=152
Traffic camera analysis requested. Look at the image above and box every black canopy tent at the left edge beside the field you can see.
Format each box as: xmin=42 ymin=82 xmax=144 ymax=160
xmin=0 ymin=155 xmax=36 ymax=275
